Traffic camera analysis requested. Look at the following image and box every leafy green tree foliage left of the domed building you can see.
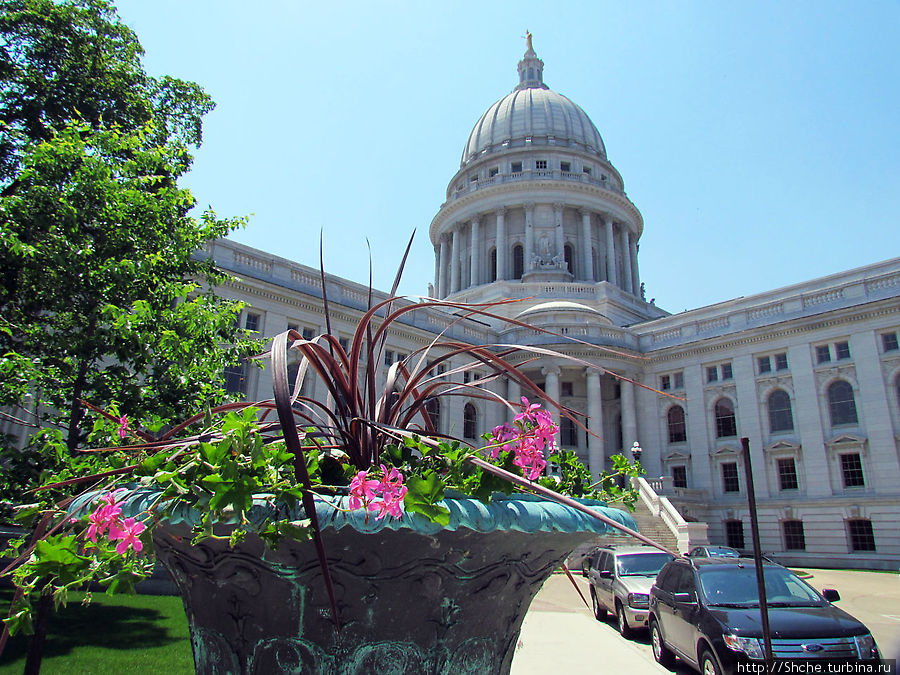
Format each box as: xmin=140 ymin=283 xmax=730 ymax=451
xmin=0 ymin=0 xmax=250 ymax=488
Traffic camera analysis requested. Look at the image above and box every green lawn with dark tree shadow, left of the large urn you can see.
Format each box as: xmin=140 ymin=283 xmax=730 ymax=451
xmin=0 ymin=589 xmax=194 ymax=675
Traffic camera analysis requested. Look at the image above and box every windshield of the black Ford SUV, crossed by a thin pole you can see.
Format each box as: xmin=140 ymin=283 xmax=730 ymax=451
xmin=698 ymin=565 xmax=825 ymax=607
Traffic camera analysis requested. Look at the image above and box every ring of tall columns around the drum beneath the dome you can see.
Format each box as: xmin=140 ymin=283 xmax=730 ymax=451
xmin=435 ymin=202 xmax=641 ymax=298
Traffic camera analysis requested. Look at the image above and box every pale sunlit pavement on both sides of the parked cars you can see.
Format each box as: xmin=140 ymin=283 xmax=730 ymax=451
xmin=512 ymin=570 xmax=900 ymax=675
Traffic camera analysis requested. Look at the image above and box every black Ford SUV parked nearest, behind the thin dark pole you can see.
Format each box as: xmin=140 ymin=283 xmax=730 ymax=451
xmin=649 ymin=558 xmax=879 ymax=675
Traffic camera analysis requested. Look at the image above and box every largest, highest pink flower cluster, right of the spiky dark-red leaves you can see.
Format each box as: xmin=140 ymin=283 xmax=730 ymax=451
xmin=491 ymin=396 xmax=559 ymax=480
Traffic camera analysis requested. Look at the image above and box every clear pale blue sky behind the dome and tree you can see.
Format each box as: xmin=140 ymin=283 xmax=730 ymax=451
xmin=117 ymin=0 xmax=900 ymax=312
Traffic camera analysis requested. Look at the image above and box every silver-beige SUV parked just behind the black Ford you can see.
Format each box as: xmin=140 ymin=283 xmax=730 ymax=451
xmin=582 ymin=545 xmax=672 ymax=638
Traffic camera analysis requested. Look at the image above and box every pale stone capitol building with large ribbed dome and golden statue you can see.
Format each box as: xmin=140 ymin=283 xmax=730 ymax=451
xmin=207 ymin=36 xmax=900 ymax=570
